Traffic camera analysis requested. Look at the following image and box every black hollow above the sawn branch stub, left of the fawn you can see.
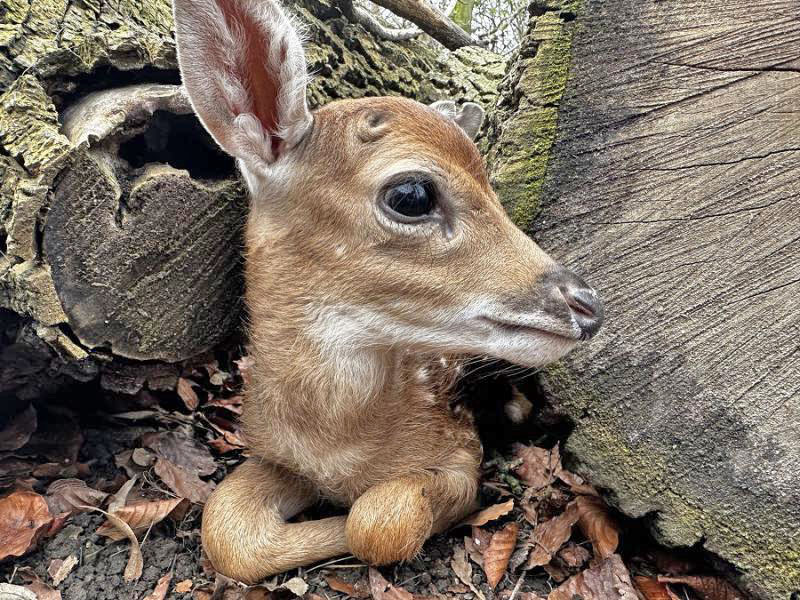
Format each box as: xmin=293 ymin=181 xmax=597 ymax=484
xmin=119 ymin=110 xmax=236 ymax=180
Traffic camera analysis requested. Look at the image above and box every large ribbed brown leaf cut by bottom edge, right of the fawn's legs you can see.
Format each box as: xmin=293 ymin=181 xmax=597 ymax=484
xmin=547 ymin=554 xmax=642 ymax=600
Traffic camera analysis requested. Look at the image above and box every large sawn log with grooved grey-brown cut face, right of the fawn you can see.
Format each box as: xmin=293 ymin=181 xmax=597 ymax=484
xmin=491 ymin=0 xmax=800 ymax=600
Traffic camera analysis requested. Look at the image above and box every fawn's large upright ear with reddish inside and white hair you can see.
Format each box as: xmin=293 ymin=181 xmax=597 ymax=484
xmin=174 ymin=0 xmax=312 ymax=167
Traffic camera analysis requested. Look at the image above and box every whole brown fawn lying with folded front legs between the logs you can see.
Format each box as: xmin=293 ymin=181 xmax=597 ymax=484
xmin=174 ymin=0 xmax=602 ymax=582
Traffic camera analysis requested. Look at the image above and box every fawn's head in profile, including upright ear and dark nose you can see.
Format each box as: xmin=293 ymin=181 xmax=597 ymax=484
xmin=175 ymin=0 xmax=602 ymax=366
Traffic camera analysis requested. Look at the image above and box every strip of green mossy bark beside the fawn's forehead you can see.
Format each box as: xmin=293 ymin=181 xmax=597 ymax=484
xmin=489 ymin=2 xmax=575 ymax=231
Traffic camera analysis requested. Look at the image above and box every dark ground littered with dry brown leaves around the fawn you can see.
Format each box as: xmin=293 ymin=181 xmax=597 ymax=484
xmin=0 ymin=346 xmax=745 ymax=600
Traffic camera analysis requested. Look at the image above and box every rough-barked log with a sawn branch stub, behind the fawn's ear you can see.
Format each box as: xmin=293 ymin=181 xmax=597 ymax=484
xmin=0 ymin=0 xmax=505 ymax=396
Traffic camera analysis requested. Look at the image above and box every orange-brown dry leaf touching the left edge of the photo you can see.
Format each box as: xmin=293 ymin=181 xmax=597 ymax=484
xmin=0 ymin=490 xmax=53 ymax=560
